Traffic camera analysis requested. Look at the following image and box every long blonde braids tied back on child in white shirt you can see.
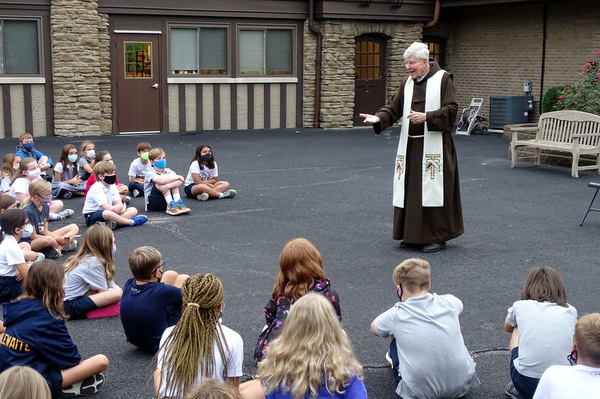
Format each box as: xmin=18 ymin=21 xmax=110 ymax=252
xmin=161 ymin=273 xmax=229 ymax=396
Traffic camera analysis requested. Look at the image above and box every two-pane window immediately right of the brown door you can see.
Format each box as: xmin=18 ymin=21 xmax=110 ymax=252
xmin=170 ymin=27 xmax=229 ymax=75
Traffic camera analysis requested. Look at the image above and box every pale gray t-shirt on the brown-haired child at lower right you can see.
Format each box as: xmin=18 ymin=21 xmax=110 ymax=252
xmin=506 ymin=299 xmax=577 ymax=378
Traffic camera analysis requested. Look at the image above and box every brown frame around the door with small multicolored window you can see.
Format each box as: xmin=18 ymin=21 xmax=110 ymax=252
xmin=110 ymin=29 xmax=163 ymax=136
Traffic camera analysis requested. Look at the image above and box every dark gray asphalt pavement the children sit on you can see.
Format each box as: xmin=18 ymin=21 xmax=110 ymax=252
xmin=0 ymin=128 xmax=600 ymax=399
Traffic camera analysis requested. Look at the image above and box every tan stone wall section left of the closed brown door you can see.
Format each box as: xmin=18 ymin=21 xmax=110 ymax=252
xmin=50 ymin=0 xmax=112 ymax=136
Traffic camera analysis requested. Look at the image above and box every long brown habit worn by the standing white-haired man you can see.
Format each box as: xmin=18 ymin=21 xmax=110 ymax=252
xmin=373 ymin=62 xmax=464 ymax=244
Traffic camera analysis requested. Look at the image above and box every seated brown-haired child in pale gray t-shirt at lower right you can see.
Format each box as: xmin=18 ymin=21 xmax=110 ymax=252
xmin=504 ymin=267 xmax=577 ymax=399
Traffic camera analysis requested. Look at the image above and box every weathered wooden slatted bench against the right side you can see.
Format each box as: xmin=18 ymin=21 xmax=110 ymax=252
xmin=510 ymin=111 xmax=600 ymax=177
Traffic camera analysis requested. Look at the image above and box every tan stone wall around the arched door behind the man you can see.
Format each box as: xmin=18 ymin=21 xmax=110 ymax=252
xmin=303 ymin=20 xmax=423 ymax=129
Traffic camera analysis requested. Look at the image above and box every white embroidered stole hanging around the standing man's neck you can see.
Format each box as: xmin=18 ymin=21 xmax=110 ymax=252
xmin=393 ymin=70 xmax=445 ymax=208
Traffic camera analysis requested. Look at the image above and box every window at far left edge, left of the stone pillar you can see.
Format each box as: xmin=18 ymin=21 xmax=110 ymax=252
xmin=0 ymin=19 xmax=40 ymax=75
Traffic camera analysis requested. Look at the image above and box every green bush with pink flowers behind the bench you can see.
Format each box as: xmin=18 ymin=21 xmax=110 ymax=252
xmin=557 ymin=51 xmax=600 ymax=115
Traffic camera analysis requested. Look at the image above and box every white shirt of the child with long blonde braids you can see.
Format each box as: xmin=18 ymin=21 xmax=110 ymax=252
xmin=156 ymin=325 xmax=244 ymax=399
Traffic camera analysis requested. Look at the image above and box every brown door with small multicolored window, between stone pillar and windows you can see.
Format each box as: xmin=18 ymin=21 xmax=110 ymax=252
xmin=116 ymin=34 xmax=162 ymax=134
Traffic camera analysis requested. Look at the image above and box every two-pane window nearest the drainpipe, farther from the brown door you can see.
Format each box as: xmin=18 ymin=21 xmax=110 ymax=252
xmin=238 ymin=29 xmax=294 ymax=76
